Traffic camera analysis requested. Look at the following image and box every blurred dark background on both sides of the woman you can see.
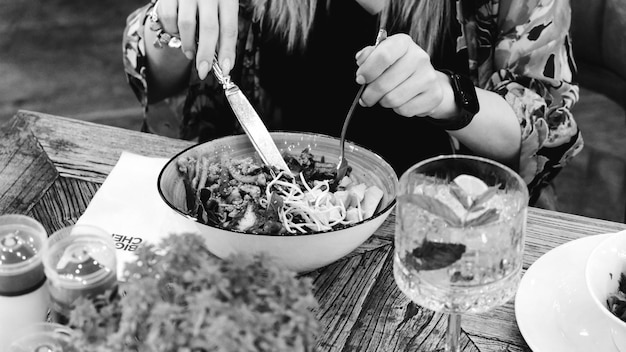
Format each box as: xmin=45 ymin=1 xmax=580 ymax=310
xmin=0 ymin=0 xmax=626 ymax=222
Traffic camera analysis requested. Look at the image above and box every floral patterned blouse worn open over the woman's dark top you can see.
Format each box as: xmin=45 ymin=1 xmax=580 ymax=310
xmin=123 ymin=0 xmax=583 ymax=204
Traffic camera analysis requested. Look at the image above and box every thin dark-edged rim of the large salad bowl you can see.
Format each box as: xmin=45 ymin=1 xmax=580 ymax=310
xmin=156 ymin=130 xmax=399 ymax=238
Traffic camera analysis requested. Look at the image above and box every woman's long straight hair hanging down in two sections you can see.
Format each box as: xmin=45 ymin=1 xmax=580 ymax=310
xmin=250 ymin=0 xmax=453 ymax=55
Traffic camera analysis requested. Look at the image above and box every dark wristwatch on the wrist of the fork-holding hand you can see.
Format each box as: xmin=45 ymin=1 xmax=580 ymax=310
xmin=428 ymin=70 xmax=480 ymax=131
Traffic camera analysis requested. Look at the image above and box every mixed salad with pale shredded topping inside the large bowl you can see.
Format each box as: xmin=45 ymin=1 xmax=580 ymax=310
xmin=178 ymin=149 xmax=383 ymax=235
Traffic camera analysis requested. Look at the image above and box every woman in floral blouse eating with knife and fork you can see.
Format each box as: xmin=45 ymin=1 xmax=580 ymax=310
xmin=124 ymin=0 xmax=583 ymax=204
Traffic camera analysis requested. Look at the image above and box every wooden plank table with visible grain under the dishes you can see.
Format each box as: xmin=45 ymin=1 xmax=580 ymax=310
xmin=0 ymin=111 xmax=626 ymax=351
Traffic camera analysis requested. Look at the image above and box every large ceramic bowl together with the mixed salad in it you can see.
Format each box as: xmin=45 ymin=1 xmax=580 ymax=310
xmin=157 ymin=132 xmax=398 ymax=273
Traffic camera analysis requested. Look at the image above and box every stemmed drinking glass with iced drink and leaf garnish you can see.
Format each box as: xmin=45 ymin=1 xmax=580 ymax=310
xmin=394 ymin=155 xmax=528 ymax=352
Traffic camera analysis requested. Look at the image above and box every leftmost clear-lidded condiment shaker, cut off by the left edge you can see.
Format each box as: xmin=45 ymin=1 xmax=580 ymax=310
xmin=0 ymin=214 xmax=49 ymax=352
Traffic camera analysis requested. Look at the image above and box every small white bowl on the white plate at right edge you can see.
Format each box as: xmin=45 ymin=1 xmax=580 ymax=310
xmin=585 ymin=231 xmax=626 ymax=352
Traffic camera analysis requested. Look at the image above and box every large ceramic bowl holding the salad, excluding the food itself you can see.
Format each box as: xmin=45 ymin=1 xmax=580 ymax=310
xmin=157 ymin=132 xmax=398 ymax=273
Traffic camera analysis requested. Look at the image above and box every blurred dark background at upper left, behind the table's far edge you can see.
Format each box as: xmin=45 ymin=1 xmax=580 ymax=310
xmin=0 ymin=0 xmax=148 ymax=128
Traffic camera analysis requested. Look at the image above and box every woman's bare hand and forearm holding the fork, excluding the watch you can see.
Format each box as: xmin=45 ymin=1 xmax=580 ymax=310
xmin=356 ymin=34 xmax=521 ymax=167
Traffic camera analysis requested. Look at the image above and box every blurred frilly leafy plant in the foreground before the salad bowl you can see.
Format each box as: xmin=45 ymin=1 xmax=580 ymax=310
xmin=70 ymin=234 xmax=319 ymax=352
